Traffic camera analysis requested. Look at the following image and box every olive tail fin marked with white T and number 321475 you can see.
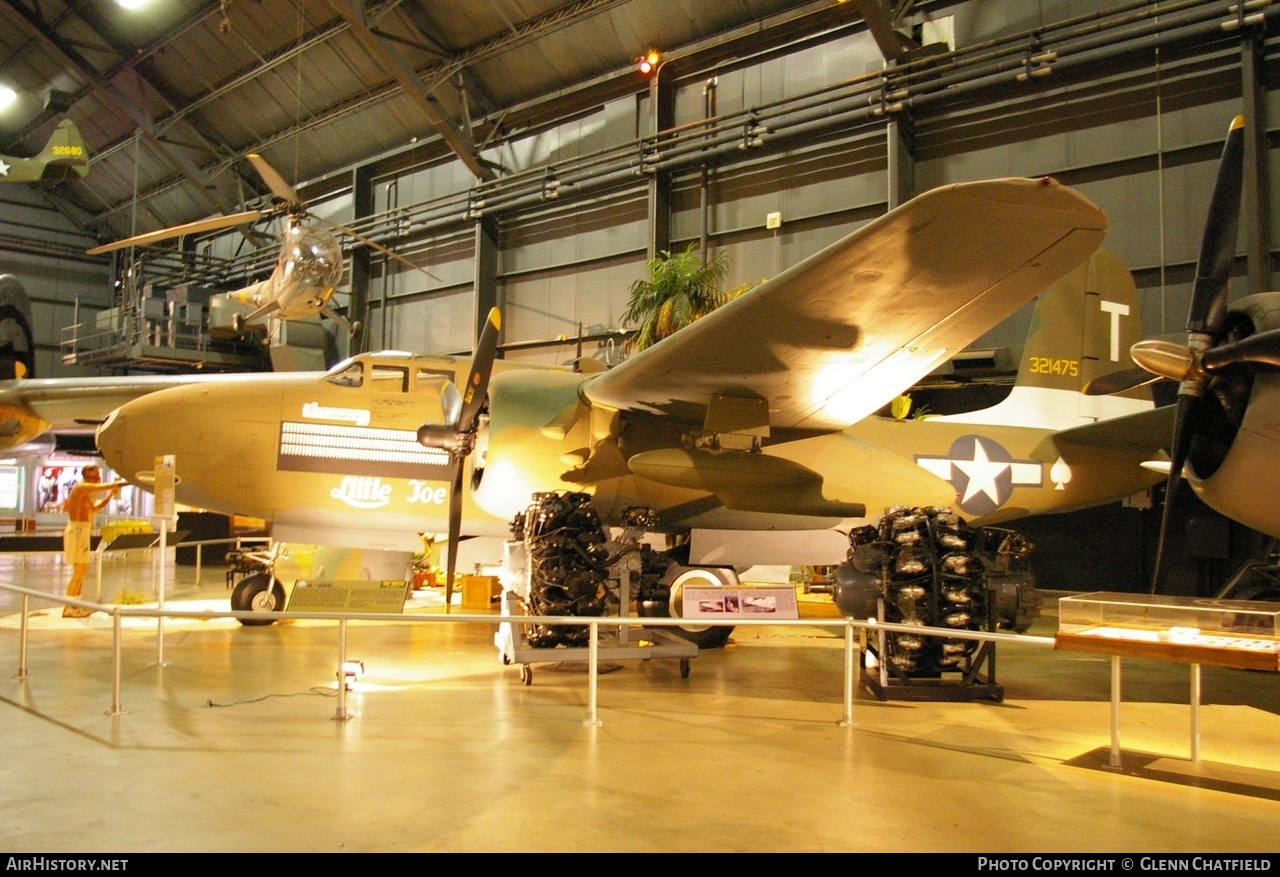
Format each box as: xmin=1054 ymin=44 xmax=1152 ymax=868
xmin=947 ymin=250 xmax=1152 ymax=429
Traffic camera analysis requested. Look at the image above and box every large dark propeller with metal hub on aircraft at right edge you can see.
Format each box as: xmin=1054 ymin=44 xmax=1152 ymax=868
xmin=1130 ymin=115 xmax=1244 ymax=594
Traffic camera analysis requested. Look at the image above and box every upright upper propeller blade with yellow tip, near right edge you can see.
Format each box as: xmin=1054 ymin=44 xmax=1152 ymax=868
xmin=1187 ymin=115 xmax=1244 ymax=338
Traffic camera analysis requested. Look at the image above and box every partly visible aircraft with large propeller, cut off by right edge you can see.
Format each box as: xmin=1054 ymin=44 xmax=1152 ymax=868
xmin=1116 ymin=117 xmax=1280 ymax=593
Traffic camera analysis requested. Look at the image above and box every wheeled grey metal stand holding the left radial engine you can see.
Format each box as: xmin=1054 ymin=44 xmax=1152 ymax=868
xmin=493 ymin=590 xmax=698 ymax=685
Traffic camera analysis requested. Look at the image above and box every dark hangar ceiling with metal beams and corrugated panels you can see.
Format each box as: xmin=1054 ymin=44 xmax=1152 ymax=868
xmin=0 ymin=0 xmax=921 ymax=239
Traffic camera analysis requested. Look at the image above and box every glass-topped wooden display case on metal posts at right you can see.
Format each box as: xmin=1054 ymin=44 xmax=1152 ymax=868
xmin=1055 ymin=591 xmax=1280 ymax=671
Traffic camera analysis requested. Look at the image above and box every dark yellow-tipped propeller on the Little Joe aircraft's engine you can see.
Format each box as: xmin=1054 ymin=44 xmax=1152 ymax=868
xmin=417 ymin=307 xmax=502 ymax=612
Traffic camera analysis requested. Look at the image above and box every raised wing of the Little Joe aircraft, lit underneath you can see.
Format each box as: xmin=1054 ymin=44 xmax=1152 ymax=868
xmin=585 ymin=178 xmax=1107 ymax=431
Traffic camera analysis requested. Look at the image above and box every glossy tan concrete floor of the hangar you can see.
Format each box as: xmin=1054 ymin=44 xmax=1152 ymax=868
xmin=0 ymin=556 xmax=1280 ymax=853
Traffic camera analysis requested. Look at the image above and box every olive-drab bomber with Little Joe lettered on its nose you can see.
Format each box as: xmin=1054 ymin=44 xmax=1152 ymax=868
xmin=90 ymin=179 xmax=1169 ymax=630
